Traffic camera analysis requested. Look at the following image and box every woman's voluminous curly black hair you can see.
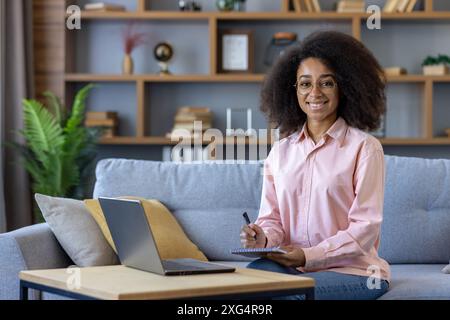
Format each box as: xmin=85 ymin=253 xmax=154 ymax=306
xmin=261 ymin=31 xmax=386 ymax=136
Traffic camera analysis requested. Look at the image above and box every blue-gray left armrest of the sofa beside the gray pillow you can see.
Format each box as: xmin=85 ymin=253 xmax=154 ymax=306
xmin=0 ymin=223 xmax=73 ymax=300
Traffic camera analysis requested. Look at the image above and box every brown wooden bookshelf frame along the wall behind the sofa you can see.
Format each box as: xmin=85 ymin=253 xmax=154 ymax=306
xmin=34 ymin=0 xmax=450 ymax=146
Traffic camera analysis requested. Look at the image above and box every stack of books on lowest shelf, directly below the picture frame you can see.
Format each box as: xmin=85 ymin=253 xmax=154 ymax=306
xmin=166 ymin=106 xmax=212 ymax=138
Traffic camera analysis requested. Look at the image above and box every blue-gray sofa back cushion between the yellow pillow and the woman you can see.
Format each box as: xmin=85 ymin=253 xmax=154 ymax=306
xmin=94 ymin=159 xmax=262 ymax=261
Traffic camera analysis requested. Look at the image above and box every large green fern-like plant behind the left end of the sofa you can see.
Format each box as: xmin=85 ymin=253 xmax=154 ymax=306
xmin=8 ymin=84 xmax=101 ymax=222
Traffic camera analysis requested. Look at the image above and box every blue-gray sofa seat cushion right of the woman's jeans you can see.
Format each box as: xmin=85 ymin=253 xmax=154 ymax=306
xmin=380 ymin=264 xmax=450 ymax=300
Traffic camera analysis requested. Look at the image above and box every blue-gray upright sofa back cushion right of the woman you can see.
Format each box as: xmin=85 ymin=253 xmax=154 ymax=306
xmin=379 ymin=156 xmax=450 ymax=264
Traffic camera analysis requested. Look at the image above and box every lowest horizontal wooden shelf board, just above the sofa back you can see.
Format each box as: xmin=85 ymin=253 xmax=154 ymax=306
xmin=100 ymin=136 xmax=450 ymax=146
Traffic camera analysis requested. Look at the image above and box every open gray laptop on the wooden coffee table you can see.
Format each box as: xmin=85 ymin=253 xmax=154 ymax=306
xmin=99 ymin=197 xmax=236 ymax=275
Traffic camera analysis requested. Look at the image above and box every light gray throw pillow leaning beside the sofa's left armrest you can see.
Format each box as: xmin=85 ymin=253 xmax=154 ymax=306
xmin=35 ymin=193 xmax=119 ymax=267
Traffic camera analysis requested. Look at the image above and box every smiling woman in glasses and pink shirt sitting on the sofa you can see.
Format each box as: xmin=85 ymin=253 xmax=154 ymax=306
xmin=241 ymin=31 xmax=390 ymax=299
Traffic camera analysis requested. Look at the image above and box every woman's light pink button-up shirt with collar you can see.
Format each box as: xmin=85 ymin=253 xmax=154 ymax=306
xmin=256 ymin=118 xmax=390 ymax=281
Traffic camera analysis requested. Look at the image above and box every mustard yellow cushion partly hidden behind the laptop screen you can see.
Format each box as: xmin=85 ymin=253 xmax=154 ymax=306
xmin=84 ymin=197 xmax=207 ymax=261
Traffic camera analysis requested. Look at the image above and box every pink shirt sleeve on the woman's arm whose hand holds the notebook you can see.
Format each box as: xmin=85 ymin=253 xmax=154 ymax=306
xmin=303 ymin=150 xmax=385 ymax=271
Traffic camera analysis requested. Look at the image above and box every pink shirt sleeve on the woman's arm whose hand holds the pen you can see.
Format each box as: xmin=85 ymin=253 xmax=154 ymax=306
xmin=255 ymin=144 xmax=285 ymax=248
